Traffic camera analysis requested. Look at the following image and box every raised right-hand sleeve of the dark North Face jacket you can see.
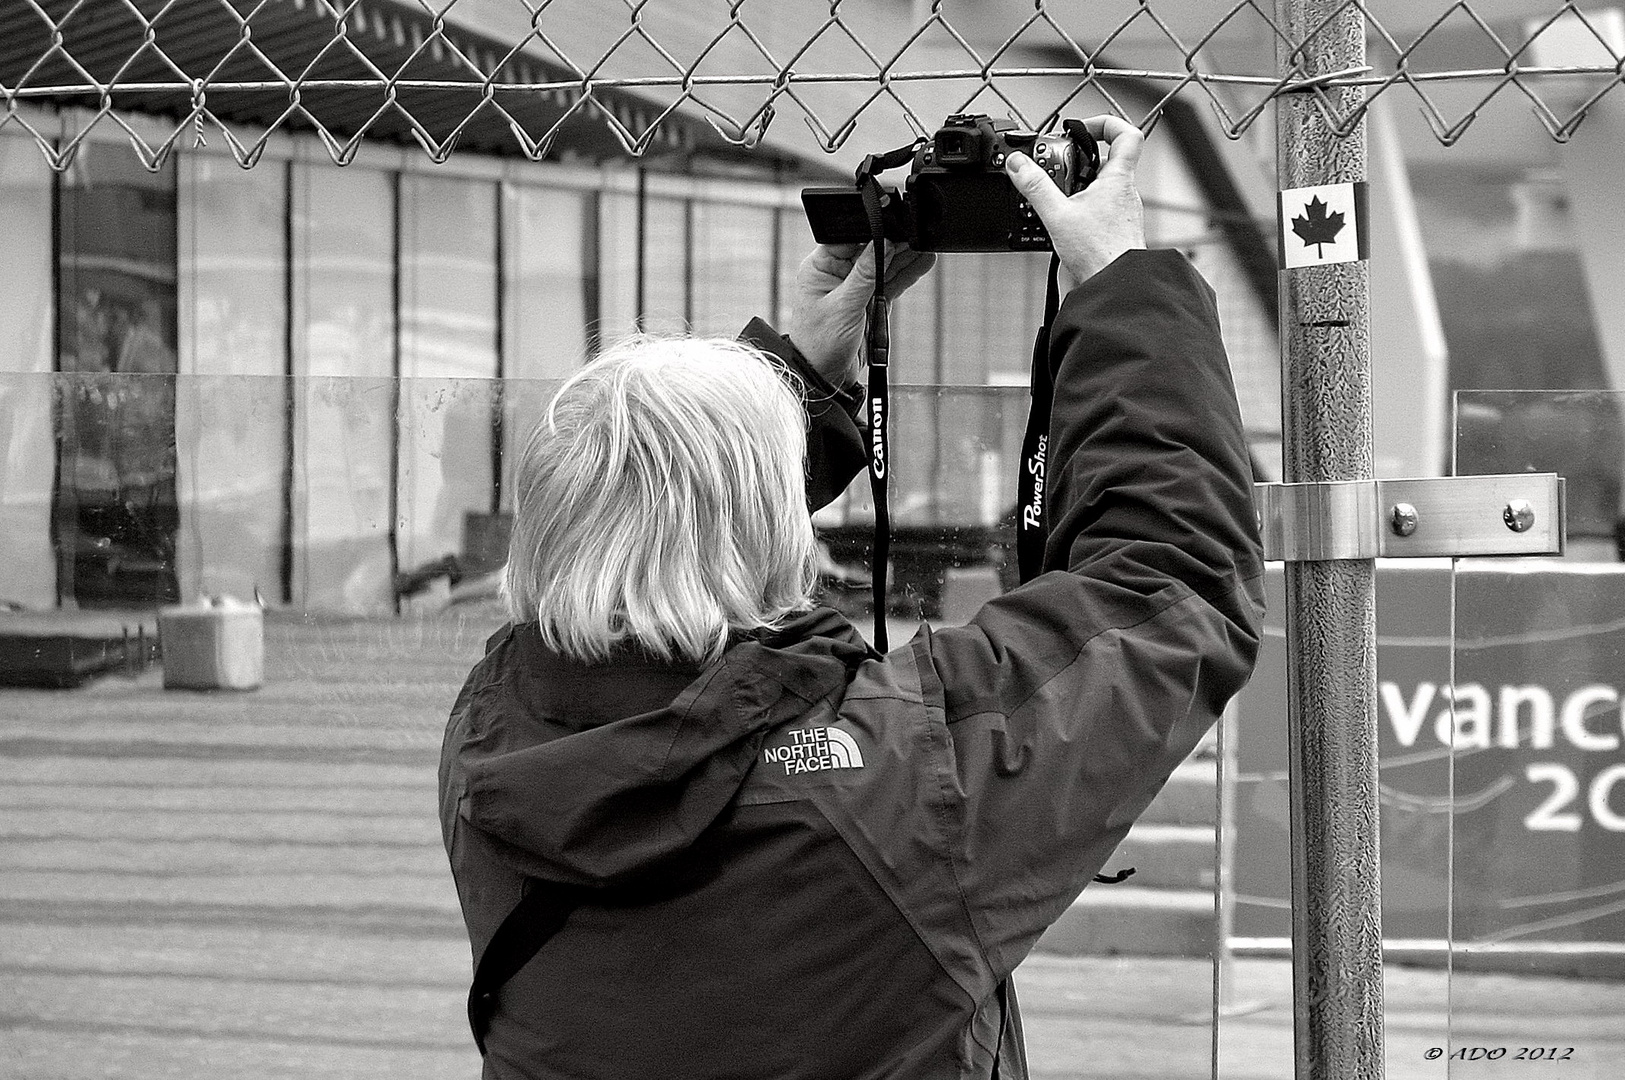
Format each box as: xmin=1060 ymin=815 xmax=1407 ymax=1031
xmin=923 ymin=250 xmax=1263 ymax=971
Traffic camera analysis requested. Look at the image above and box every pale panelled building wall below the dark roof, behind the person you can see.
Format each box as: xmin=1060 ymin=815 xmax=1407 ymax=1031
xmin=0 ymin=92 xmax=1279 ymax=612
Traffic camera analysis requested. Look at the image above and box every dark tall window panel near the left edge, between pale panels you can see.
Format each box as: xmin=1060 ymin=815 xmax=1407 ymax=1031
xmin=54 ymin=143 xmax=180 ymax=607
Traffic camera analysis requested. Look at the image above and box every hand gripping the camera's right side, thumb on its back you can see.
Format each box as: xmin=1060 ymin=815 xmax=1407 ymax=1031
xmin=1004 ymin=117 xmax=1146 ymax=284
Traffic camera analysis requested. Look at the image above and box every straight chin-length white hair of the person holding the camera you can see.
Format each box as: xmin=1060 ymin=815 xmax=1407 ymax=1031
xmin=502 ymin=336 xmax=816 ymax=663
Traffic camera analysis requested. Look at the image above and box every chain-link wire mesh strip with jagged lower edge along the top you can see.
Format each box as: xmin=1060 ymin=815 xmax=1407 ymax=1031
xmin=0 ymin=0 xmax=1625 ymax=169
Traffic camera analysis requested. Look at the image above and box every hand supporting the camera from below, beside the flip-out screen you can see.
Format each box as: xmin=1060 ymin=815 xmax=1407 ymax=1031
xmin=790 ymin=240 xmax=936 ymax=387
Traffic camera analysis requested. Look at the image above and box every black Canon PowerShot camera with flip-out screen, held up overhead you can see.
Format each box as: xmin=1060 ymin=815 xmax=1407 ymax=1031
xmin=801 ymin=114 xmax=1100 ymax=252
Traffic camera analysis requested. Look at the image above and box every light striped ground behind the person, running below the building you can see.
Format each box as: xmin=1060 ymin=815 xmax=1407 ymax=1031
xmin=0 ymin=609 xmax=1625 ymax=1080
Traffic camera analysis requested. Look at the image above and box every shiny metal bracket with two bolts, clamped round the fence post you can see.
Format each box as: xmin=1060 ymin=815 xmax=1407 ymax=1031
xmin=1255 ymin=473 xmax=1567 ymax=562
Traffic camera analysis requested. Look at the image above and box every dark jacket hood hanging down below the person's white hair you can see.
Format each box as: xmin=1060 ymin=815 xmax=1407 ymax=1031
xmin=458 ymin=607 xmax=879 ymax=885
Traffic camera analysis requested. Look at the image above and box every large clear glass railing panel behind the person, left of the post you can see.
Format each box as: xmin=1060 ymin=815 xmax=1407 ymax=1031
xmin=0 ymin=375 xmax=1222 ymax=1080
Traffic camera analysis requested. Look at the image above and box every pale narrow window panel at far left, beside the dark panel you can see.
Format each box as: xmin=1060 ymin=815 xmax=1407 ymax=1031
xmin=0 ymin=136 xmax=57 ymax=607
